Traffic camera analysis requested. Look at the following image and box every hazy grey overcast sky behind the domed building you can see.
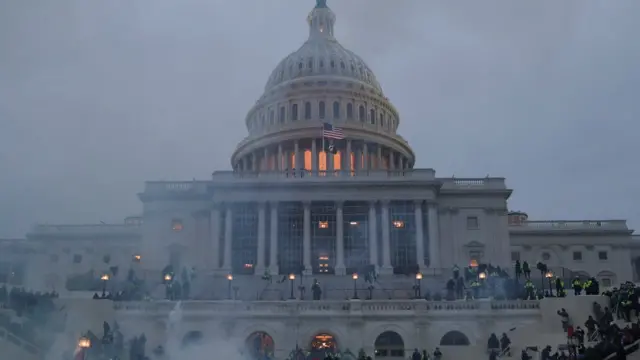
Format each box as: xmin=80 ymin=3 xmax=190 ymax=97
xmin=0 ymin=0 xmax=640 ymax=237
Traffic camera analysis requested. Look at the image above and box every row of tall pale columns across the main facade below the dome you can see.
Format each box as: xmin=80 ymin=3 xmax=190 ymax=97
xmin=211 ymin=200 xmax=440 ymax=275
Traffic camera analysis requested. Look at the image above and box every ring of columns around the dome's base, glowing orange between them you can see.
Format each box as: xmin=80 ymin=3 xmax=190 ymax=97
xmin=234 ymin=138 xmax=413 ymax=172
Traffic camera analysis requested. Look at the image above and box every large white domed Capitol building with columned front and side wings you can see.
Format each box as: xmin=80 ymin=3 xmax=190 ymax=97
xmin=0 ymin=1 xmax=640 ymax=358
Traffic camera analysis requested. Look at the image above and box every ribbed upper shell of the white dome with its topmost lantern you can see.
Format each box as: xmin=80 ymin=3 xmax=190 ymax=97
xmin=265 ymin=4 xmax=382 ymax=93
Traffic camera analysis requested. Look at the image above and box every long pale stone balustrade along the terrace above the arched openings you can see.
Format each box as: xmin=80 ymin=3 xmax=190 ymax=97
xmin=114 ymin=300 xmax=540 ymax=316
